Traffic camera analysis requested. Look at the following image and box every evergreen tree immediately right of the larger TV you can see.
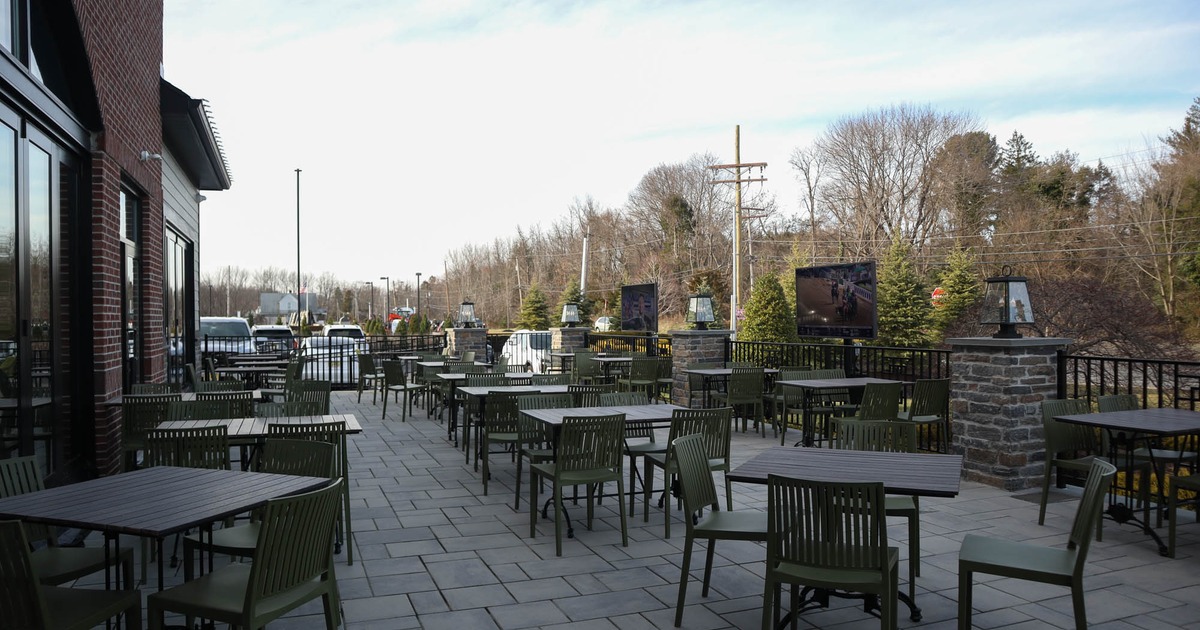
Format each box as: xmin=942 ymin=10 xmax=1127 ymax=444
xmin=875 ymin=238 xmax=931 ymax=348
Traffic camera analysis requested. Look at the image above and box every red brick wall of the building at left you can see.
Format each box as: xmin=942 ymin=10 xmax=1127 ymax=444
xmin=74 ymin=0 xmax=166 ymax=474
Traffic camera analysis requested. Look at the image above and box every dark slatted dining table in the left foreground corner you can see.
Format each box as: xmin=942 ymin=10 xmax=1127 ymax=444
xmin=0 ymin=466 xmax=329 ymax=590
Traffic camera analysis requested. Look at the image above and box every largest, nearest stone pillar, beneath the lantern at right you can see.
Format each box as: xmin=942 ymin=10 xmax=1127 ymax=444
xmin=946 ymin=337 xmax=1074 ymax=491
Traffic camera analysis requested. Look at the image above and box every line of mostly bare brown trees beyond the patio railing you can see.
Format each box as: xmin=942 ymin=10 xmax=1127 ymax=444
xmin=202 ymin=98 xmax=1200 ymax=356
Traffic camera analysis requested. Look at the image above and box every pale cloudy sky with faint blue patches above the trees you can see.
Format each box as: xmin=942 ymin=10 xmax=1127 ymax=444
xmin=163 ymin=0 xmax=1200 ymax=289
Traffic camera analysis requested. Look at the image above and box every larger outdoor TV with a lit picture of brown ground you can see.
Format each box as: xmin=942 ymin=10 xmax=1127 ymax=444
xmin=796 ymin=260 xmax=878 ymax=340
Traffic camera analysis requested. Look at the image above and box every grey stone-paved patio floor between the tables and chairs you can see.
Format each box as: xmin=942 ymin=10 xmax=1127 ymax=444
xmin=119 ymin=392 xmax=1200 ymax=630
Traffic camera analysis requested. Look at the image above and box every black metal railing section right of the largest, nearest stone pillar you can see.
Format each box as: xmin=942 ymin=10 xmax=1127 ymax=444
xmin=1057 ymin=352 xmax=1200 ymax=409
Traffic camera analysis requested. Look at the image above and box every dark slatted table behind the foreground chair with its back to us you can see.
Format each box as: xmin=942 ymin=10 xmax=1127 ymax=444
xmin=728 ymin=446 xmax=962 ymax=622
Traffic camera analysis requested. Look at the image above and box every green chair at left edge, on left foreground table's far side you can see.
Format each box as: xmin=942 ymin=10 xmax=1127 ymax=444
xmin=0 ymin=455 xmax=133 ymax=588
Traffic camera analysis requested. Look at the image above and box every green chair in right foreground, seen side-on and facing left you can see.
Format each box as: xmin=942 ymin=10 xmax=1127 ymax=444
xmin=959 ymin=460 xmax=1117 ymax=630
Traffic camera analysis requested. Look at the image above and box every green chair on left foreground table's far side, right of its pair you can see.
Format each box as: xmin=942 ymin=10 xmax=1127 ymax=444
xmin=184 ymin=438 xmax=337 ymax=581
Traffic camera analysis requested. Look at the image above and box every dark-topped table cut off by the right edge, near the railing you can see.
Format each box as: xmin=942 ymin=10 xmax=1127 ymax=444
xmin=1054 ymin=407 xmax=1200 ymax=557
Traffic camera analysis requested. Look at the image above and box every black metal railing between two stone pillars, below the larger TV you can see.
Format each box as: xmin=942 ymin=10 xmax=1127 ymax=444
xmin=725 ymin=341 xmax=950 ymax=382
